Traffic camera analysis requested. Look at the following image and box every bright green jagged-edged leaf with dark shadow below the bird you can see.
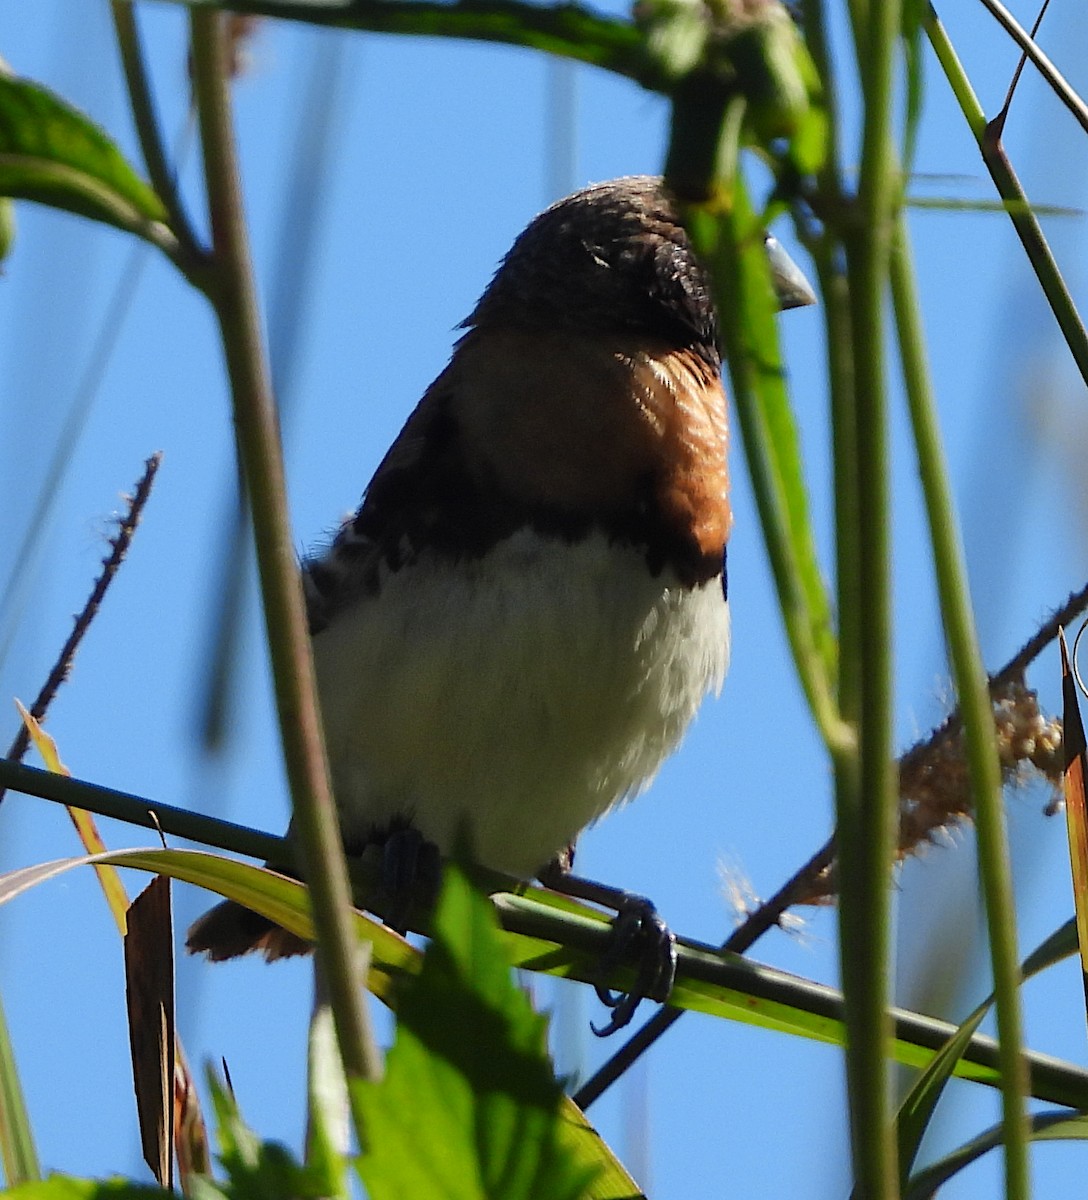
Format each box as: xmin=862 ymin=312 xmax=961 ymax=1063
xmin=353 ymin=868 xmax=609 ymax=1200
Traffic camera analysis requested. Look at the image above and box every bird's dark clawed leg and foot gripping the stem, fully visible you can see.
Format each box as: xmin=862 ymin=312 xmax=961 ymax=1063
xmin=539 ymin=846 xmax=677 ymax=1038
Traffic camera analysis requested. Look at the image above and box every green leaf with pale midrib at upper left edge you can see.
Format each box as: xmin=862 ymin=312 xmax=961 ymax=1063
xmin=0 ymin=76 xmax=166 ymax=235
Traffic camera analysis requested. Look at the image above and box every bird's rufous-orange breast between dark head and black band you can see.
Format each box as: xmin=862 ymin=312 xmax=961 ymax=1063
xmin=453 ymin=329 xmax=732 ymax=583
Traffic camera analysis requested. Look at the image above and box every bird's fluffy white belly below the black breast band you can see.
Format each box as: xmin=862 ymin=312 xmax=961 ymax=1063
xmin=314 ymin=532 xmax=729 ymax=876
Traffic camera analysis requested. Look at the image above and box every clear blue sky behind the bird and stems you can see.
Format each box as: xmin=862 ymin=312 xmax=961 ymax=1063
xmin=0 ymin=0 xmax=1088 ymax=1200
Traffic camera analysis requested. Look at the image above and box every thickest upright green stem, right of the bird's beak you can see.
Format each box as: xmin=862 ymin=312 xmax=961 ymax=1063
xmin=836 ymin=0 xmax=900 ymax=1200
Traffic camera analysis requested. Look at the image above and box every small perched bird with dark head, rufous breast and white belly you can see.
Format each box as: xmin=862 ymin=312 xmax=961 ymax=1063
xmin=187 ymin=176 xmax=815 ymax=998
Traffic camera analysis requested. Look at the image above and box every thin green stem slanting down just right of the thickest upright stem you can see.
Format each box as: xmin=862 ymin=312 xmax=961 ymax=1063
xmin=891 ymin=221 xmax=1028 ymax=1200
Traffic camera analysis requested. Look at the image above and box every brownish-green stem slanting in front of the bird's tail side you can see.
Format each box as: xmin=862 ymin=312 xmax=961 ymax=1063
xmin=190 ymin=8 xmax=378 ymax=1099
